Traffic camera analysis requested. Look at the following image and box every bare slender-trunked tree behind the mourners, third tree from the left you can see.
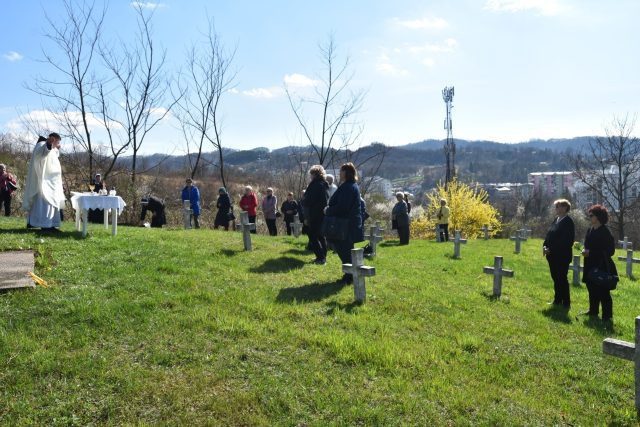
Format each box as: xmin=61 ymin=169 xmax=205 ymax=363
xmin=178 ymin=21 xmax=236 ymax=187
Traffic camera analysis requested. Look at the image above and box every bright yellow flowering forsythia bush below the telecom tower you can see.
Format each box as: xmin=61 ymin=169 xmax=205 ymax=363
xmin=411 ymin=180 xmax=502 ymax=239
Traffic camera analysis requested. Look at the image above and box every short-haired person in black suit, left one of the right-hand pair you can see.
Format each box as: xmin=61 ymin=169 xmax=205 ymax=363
xmin=543 ymin=199 xmax=575 ymax=309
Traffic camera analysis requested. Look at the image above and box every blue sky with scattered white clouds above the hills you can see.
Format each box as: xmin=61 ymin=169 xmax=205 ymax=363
xmin=0 ymin=0 xmax=640 ymax=153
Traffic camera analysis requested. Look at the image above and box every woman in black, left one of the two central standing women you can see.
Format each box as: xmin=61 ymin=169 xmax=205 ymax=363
xmin=304 ymin=165 xmax=329 ymax=265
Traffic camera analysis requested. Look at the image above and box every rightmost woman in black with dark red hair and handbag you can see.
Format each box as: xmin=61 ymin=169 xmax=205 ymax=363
xmin=582 ymin=205 xmax=618 ymax=321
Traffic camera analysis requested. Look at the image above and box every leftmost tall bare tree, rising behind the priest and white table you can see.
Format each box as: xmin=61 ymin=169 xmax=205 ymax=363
xmin=25 ymin=0 xmax=106 ymax=178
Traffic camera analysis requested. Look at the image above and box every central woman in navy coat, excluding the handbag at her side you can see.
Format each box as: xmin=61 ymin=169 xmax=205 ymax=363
xmin=325 ymin=162 xmax=364 ymax=283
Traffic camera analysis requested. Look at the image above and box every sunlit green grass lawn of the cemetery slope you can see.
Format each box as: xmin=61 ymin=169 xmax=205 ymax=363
xmin=0 ymin=219 xmax=640 ymax=425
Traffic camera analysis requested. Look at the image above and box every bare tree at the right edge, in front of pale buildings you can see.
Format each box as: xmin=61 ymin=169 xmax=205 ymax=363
xmin=569 ymin=116 xmax=640 ymax=239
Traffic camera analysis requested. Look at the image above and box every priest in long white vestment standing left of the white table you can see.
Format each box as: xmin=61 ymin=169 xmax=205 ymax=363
xmin=22 ymin=133 xmax=65 ymax=229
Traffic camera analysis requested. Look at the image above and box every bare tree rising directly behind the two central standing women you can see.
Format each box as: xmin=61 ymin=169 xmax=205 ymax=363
xmin=285 ymin=36 xmax=365 ymax=167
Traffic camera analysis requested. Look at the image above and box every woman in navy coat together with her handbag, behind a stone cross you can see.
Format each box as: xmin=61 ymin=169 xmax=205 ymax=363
xmin=323 ymin=162 xmax=364 ymax=283
